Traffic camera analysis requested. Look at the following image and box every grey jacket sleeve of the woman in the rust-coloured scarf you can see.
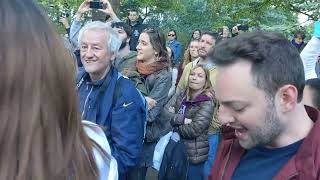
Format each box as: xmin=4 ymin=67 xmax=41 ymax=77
xmin=147 ymin=72 xmax=171 ymax=122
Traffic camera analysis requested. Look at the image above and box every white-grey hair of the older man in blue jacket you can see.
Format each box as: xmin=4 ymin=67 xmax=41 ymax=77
xmin=78 ymin=21 xmax=121 ymax=53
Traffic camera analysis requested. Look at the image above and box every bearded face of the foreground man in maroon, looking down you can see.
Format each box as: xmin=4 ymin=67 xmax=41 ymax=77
xmin=215 ymin=60 xmax=284 ymax=149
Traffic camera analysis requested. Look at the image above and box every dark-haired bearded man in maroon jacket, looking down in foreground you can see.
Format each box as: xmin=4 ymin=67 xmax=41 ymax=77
xmin=208 ymin=32 xmax=320 ymax=180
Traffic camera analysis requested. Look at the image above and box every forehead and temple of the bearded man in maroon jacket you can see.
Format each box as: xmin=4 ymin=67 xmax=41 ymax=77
xmin=216 ymin=61 xmax=265 ymax=103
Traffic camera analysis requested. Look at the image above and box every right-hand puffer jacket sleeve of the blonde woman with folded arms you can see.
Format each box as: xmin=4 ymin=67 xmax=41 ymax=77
xmin=178 ymin=101 xmax=214 ymax=139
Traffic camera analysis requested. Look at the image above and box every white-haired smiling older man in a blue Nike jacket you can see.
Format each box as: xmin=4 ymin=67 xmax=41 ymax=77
xmin=77 ymin=21 xmax=146 ymax=180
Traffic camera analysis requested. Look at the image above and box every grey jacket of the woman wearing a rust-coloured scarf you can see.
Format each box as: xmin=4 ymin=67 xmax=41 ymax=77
xmin=145 ymin=68 xmax=172 ymax=143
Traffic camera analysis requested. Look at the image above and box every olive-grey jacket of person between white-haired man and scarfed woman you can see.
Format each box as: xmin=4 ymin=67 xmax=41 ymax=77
xmin=114 ymin=51 xmax=147 ymax=95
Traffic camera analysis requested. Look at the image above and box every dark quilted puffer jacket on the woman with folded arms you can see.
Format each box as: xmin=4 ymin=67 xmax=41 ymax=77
xmin=165 ymin=92 xmax=215 ymax=164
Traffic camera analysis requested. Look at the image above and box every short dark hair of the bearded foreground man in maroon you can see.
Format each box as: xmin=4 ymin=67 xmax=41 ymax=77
xmin=208 ymin=32 xmax=305 ymax=102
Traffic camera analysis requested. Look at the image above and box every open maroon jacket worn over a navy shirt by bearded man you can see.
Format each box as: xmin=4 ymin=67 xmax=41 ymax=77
xmin=209 ymin=106 xmax=320 ymax=180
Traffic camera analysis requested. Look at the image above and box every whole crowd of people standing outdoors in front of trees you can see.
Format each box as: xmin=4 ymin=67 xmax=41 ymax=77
xmin=0 ymin=0 xmax=320 ymax=180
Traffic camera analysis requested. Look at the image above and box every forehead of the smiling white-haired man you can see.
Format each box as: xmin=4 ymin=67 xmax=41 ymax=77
xmin=81 ymin=29 xmax=107 ymax=44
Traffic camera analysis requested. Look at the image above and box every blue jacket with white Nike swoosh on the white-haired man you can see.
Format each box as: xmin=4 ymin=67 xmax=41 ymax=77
xmin=77 ymin=67 xmax=146 ymax=179
